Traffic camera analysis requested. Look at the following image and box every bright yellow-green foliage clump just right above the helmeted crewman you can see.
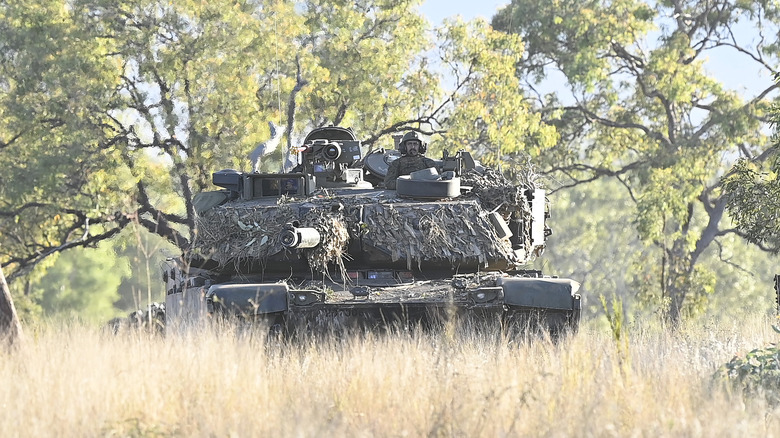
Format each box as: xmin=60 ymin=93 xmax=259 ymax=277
xmin=434 ymin=20 xmax=558 ymax=164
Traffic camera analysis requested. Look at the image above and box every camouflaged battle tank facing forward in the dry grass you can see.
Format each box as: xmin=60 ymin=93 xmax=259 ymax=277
xmin=163 ymin=127 xmax=582 ymax=333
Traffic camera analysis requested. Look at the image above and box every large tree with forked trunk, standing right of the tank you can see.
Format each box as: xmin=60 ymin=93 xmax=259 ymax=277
xmin=493 ymin=0 xmax=780 ymax=322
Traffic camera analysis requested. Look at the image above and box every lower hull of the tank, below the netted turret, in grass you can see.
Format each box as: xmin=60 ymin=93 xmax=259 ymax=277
xmin=166 ymin=271 xmax=582 ymax=336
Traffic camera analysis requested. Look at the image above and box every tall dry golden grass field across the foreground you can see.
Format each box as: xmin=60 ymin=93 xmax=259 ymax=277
xmin=0 ymin=317 xmax=780 ymax=437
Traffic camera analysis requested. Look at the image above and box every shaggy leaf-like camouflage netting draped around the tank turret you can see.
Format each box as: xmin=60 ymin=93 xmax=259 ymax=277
xmin=192 ymin=169 xmax=533 ymax=272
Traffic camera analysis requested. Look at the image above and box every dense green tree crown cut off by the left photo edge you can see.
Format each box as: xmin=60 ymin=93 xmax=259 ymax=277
xmin=0 ymin=1 xmax=124 ymax=282
